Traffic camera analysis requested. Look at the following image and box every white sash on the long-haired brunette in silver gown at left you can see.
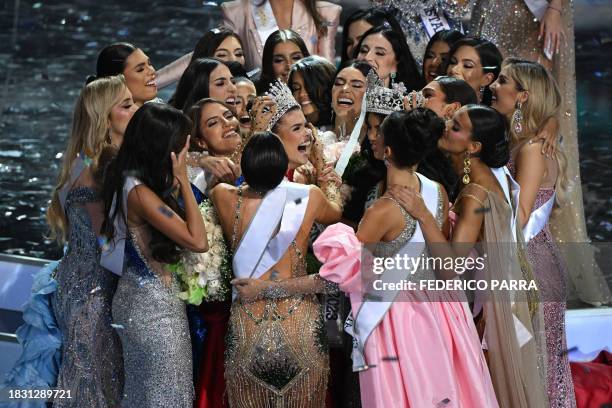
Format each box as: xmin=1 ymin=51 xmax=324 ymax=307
xmin=100 ymin=176 xmax=142 ymax=276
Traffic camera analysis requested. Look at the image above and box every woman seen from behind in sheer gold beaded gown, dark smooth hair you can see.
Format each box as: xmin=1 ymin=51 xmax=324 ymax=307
xmin=211 ymin=132 xmax=341 ymax=408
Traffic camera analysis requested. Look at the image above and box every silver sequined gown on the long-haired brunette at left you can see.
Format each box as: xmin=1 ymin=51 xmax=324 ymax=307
xmin=113 ymin=224 xmax=194 ymax=408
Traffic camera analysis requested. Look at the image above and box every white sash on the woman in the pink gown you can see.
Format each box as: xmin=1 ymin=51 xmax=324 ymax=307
xmin=344 ymin=173 xmax=438 ymax=371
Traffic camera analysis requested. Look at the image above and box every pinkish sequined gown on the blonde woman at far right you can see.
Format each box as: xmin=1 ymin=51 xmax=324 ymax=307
xmin=508 ymin=161 xmax=576 ymax=408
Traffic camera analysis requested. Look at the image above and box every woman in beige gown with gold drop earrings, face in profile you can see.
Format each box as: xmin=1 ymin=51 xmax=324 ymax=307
xmin=390 ymin=105 xmax=548 ymax=408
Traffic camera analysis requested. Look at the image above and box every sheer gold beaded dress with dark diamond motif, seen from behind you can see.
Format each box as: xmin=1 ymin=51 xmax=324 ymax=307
xmin=225 ymin=190 xmax=331 ymax=408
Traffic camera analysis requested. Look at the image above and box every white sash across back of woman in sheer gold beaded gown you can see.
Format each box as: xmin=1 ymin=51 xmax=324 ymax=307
xmin=232 ymin=181 xmax=310 ymax=286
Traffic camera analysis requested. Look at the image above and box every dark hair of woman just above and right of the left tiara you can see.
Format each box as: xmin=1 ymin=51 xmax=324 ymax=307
xmin=288 ymin=55 xmax=336 ymax=127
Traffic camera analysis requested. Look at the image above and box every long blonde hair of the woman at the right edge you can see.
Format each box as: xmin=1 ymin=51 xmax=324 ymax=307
xmin=502 ymin=58 xmax=568 ymax=204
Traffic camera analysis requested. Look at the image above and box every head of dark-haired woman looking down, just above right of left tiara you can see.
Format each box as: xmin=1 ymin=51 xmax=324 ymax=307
xmin=288 ymin=55 xmax=336 ymax=130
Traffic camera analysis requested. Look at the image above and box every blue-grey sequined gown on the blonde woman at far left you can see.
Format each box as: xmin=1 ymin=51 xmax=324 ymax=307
xmin=51 ymin=186 xmax=123 ymax=408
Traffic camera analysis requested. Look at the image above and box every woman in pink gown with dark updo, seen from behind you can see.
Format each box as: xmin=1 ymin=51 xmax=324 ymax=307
xmin=313 ymin=108 xmax=497 ymax=407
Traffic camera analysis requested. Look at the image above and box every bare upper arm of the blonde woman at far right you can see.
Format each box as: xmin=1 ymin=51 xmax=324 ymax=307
xmin=515 ymin=143 xmax=546 ymax=228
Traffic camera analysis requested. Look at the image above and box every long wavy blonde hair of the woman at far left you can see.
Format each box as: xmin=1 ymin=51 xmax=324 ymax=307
xmin=47 ymin=75 xmax=126 ymax=244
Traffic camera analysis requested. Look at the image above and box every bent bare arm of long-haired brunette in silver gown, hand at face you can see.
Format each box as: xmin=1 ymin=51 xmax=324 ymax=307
xmin=128 ymin=137 xmax=208 ymax=252
